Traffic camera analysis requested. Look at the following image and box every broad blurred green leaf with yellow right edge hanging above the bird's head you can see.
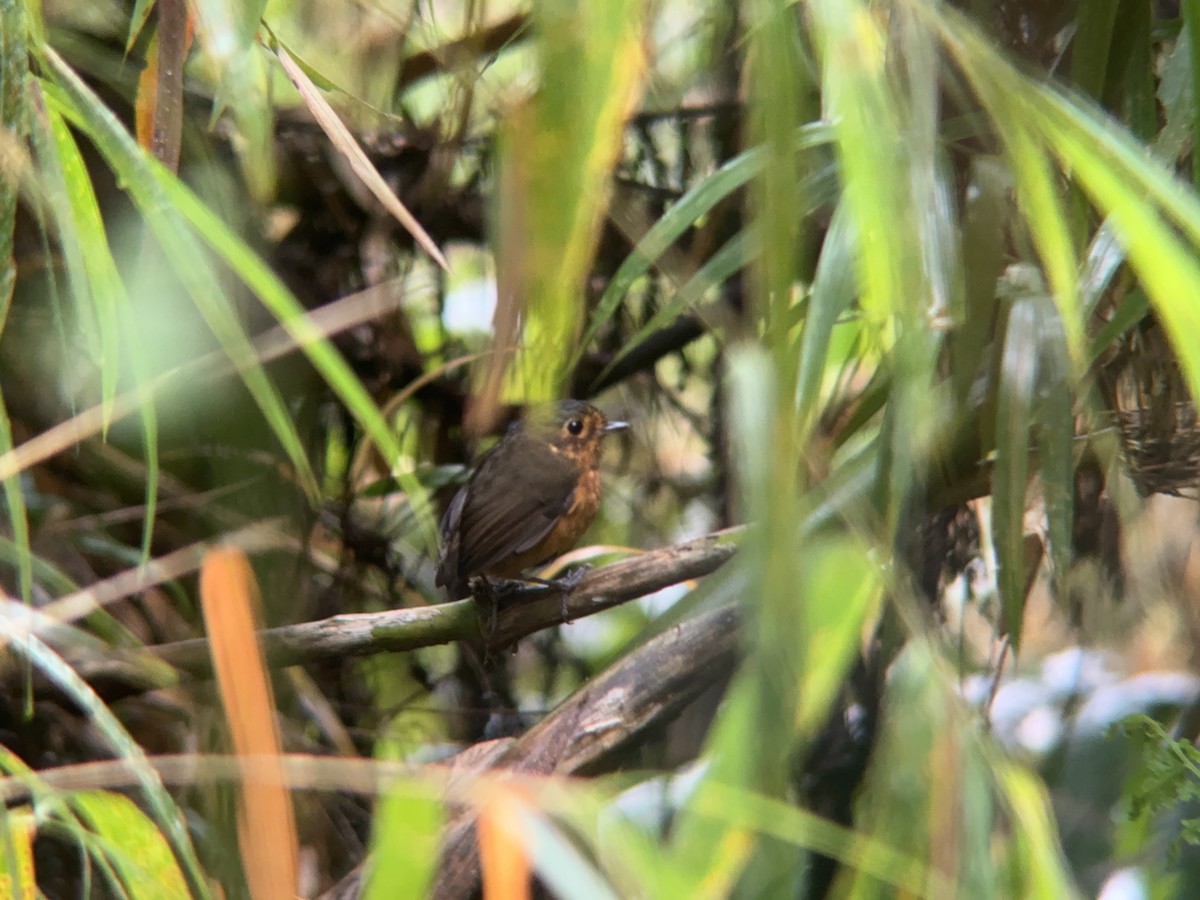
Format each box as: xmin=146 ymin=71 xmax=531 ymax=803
xmin=496 ymin=0 xmax=644 ymax=400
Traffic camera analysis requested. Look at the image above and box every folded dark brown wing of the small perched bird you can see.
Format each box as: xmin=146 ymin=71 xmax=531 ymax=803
xmin=451 ymin=450 xmax=576 ymax=577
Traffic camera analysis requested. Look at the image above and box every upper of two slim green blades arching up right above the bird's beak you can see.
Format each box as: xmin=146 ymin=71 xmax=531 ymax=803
xmin=576 ymin=122 xmax=833 ymax=361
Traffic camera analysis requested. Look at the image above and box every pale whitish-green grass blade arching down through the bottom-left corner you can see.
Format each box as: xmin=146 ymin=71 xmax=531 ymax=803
xmin=0 ymin=614 xmax=210 ymax=898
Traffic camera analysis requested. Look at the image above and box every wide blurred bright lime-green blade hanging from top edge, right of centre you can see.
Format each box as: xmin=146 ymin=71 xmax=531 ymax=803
xmin=806 ymin=0 xmax=955 ymax=542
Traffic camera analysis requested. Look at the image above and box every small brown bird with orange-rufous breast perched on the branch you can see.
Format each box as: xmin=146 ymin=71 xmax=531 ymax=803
xmin=437 ymin=400 xmax=629 ymax=600
